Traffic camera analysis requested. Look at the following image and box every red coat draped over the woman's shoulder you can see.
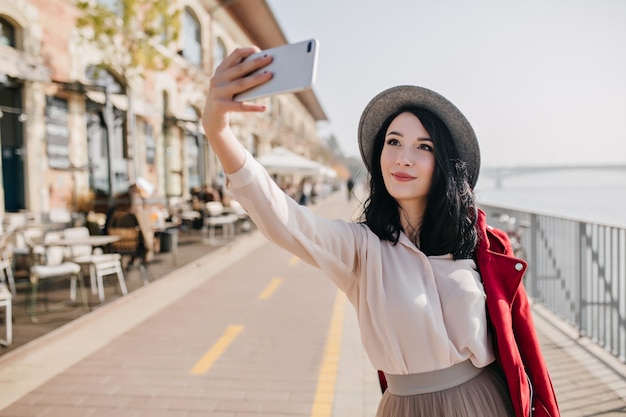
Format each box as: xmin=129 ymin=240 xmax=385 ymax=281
xmin=378 ymin=210 xmax=561 ymax=417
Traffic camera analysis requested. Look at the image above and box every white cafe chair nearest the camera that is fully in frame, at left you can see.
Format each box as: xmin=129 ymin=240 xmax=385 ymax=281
xmin=25 ymin=232 xmax=88 ymax=323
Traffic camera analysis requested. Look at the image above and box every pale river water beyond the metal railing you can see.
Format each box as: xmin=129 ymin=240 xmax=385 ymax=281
xmin=476 ymin=170 xmax=626 ymax=227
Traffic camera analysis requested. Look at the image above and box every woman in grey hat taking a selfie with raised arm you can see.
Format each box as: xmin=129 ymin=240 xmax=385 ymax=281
xmin=203 ymin=47 xmax=559 ymax=417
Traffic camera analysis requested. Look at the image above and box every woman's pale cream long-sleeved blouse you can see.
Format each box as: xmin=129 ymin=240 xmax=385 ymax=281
xmin=228 ymin=153 xmax=494 ymax=375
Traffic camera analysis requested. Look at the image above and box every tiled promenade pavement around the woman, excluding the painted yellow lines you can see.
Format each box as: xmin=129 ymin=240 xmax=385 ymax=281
xmin=0 ymin=195 xmax=626 ymax=417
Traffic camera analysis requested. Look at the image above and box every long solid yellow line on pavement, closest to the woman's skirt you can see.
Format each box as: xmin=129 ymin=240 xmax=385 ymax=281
xmin=311 ymin=291 xmax=346 ymax=417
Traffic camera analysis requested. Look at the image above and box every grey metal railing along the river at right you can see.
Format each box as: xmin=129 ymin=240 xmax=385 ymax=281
xmin=480 ymin=204 xmax=626 ymax=362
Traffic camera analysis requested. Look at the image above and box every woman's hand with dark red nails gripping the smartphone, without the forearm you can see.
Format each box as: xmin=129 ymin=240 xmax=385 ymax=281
xmin=202 ymin=46 xmax=272 ymax=136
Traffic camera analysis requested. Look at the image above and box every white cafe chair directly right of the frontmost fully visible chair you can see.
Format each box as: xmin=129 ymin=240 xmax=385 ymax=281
xmin=63 ymin=227 xmax=128 ymax=302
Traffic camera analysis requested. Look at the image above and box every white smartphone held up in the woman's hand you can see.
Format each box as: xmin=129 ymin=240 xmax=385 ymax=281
xmin=234 ymin=39 xmax=319 ymax=101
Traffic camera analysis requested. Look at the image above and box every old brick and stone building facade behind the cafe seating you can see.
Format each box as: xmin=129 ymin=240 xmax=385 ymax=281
xmin=0 ymin=0 xmax=326 ymax=218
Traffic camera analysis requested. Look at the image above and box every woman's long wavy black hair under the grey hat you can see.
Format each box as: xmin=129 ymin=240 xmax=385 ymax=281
xmin=363 ymin=106 xmax=478 ymax=259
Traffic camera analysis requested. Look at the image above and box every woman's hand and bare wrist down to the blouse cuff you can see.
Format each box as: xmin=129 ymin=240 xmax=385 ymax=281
xmin=202 ymin=46 xmax=272 ymax=174
